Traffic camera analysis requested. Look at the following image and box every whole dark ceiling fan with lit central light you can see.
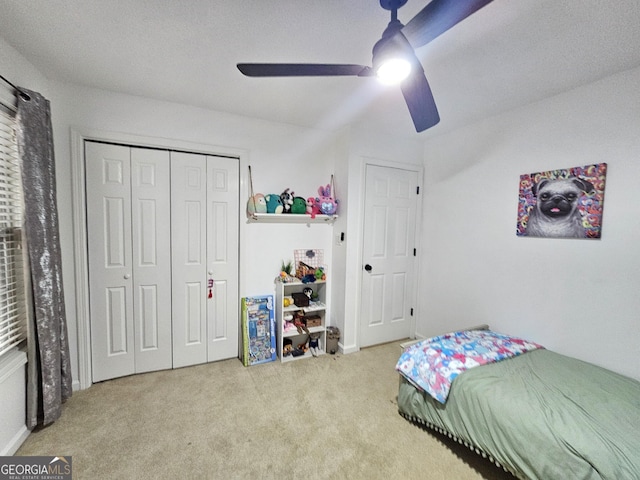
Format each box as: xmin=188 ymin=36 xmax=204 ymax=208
xmin=238 ymin=0 xmax=493 ymax=132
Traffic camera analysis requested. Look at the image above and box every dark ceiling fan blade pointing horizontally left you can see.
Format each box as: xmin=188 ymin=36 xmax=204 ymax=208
xmin=238 ymin=63 xmax=373 ymax=77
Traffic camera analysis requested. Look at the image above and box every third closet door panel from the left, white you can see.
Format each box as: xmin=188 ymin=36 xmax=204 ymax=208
xmin=171 ymin=152 xmax=207 ymax=368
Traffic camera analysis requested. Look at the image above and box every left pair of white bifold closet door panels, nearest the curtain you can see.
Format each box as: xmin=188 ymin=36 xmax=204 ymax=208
xmin=85 ymin=142 xmax=172 ymax=382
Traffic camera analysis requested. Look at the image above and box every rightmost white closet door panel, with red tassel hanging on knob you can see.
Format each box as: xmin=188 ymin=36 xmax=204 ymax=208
xmin=207 ymin=156 xmax=240 ymax=361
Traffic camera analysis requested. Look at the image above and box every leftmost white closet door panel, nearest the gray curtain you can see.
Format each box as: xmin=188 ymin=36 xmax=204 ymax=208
xmin=85 ymin=142 xmax=135 ymax=382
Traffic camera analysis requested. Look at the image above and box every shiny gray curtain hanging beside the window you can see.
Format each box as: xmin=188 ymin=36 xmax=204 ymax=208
xmin=16 ymin=89 xmax=72 ymax=428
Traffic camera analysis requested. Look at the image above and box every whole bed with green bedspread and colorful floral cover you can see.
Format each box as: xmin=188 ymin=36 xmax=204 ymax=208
xmin=396 ymin=330 xmax=640 ymax=480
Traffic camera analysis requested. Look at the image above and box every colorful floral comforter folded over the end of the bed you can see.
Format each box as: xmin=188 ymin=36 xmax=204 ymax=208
xmin=396 ymin=330 xmax=544 ymax=403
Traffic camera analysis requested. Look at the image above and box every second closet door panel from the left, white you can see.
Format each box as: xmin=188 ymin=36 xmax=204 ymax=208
xmin=131 ymin=148 xmax=173 ymax=373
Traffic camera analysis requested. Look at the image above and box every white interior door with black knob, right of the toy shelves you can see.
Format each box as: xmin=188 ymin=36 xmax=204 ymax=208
xmin=360 ymin=165 xmax=418 ymax=347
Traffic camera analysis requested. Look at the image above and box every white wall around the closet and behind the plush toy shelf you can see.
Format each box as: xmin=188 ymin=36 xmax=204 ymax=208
xmin=50 ymin=82 xmax=344 ymax=388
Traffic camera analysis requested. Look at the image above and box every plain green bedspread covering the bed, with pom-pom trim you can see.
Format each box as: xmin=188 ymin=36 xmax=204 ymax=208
xmin=398 ymin=350 xmax=640 ymax=480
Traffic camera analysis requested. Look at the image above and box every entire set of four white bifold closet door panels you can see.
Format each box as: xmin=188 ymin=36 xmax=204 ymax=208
xmin=85 ymin=142 xmax=240 ymax=382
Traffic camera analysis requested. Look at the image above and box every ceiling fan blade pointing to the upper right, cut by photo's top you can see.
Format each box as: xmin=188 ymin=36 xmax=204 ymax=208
xmin=401 ymin=0 xmax=493 ymax=48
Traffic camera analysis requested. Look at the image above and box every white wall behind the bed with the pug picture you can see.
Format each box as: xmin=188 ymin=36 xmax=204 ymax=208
xmin=418 ymin=64 xmax=640 ymax=378
